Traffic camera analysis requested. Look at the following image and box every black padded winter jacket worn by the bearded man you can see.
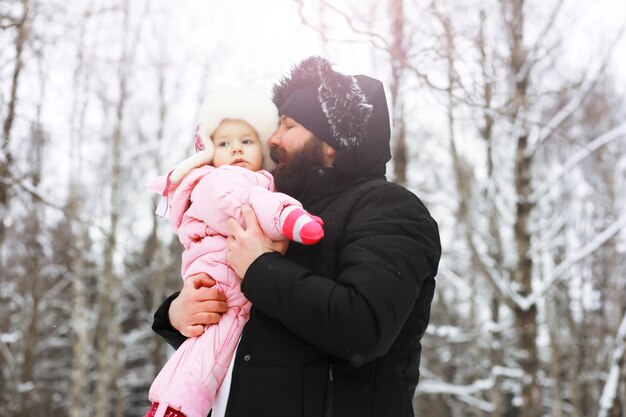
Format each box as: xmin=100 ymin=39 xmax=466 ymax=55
xmin=153 ymin=76 xmax=441 ymax=417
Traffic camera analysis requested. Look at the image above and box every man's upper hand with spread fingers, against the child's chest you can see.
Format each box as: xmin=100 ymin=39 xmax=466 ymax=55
xmin=226 ymin=205 xmax=289 ymax=278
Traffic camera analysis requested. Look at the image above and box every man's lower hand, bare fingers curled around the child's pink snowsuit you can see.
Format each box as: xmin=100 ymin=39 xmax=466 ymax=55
xmin=168 ymin=274 xmax=228 ymax=337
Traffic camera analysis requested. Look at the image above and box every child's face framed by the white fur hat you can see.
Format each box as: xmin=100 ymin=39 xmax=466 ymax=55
xmin=211 ymin=119 xmax=263 ymax=171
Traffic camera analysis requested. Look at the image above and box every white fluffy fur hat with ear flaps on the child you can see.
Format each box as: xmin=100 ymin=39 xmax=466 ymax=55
xmin=170 ymin=87 xmax=279 ymax=184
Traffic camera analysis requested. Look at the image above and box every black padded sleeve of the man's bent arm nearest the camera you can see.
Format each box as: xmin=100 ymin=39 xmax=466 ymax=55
xmin=242 ymin=186 xmax=441 ymax=364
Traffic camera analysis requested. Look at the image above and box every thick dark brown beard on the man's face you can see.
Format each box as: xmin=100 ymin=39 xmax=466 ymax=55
xmin=270 ymin=137 xmax=326 ymax=198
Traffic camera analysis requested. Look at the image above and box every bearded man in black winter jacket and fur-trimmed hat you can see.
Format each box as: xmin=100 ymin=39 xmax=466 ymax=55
xmin=153 ymin=57 xmax=441 ymax=417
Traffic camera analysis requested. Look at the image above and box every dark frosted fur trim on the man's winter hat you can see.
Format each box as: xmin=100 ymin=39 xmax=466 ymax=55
xmin=273 ymin=56 xmax=372 ymax=149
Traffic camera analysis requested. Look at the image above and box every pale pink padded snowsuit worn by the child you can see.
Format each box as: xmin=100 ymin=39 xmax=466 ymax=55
xmin=149 ymin=165 xmax=302 ymax=417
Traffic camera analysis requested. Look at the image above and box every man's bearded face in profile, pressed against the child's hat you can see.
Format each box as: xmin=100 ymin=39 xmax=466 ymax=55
xmin=269 ymin=116 xmax=326 ymax=197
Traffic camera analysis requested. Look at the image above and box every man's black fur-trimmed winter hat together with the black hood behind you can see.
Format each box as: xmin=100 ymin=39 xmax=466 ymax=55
xmin=272 ymin=56 xmax=391 ymax=176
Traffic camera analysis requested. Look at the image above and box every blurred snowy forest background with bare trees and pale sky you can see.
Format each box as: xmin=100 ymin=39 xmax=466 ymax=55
xmin=0 ymin=0 xmax=626 ymax=417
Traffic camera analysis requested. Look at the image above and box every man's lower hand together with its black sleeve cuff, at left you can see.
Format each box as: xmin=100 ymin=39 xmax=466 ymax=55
xmin=152 ymin=274 xmax=228 ymax=349
